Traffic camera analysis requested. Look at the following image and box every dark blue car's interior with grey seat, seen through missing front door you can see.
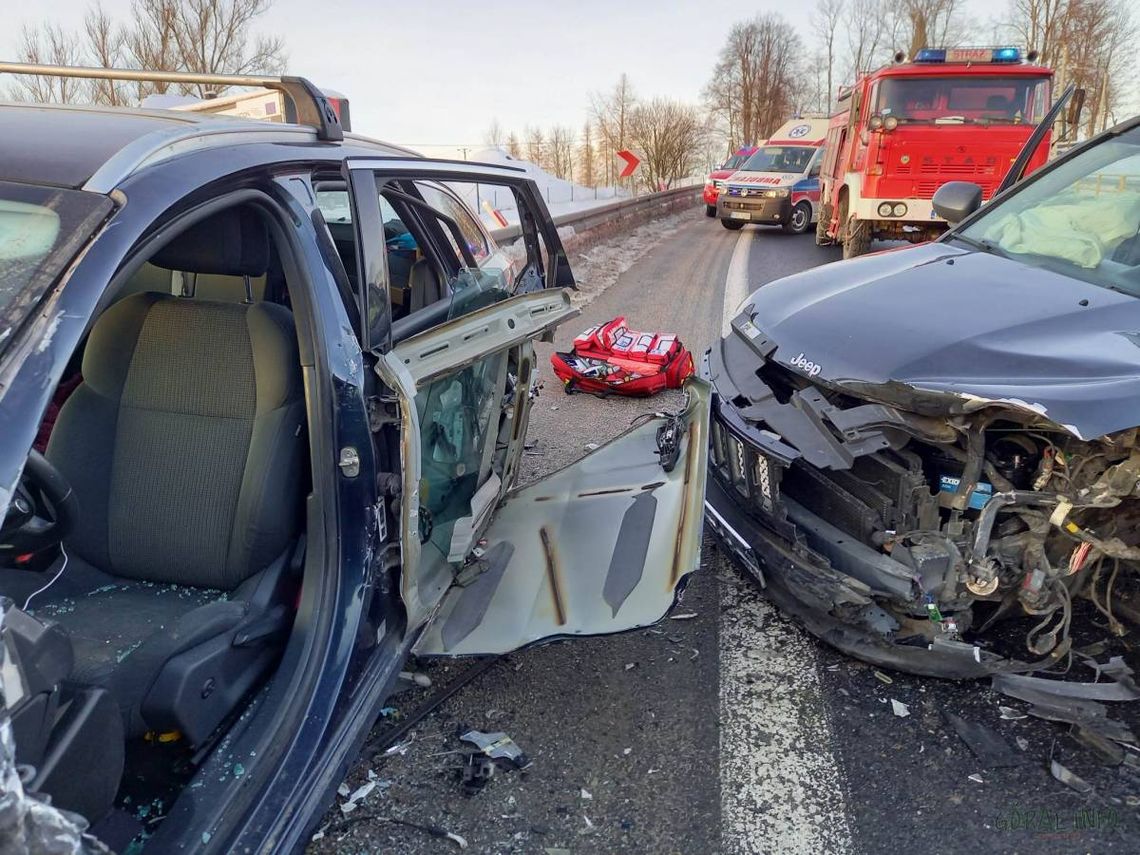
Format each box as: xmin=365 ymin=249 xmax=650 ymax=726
xmin=0 ymin=205 xmax=311 ymax=847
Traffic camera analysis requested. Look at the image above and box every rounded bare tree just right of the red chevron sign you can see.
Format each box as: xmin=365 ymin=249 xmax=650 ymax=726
xmin=629 ymin=98 xmax=705 ymax=190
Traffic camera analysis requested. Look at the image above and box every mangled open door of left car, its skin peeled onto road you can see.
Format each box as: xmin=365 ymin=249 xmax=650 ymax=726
xmin=351 ymin=162 xmax=709 ymax=656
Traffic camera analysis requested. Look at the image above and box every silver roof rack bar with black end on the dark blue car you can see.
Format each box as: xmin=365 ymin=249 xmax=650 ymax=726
xmin=0 ymin=63 xmax=344 ymax=143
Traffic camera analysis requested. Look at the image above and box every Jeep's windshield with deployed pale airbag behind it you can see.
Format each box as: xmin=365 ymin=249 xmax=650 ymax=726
xmin=954 ymin=130 xmax=1140 ymax=294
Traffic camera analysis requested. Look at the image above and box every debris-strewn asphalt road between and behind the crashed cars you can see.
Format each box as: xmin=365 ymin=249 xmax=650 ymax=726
xmin=310 ymin=210 xmax=1140 ymax=855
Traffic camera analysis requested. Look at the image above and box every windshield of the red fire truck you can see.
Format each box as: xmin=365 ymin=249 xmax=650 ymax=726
xmin=873 ymin=75 xmax=1049 ymax=124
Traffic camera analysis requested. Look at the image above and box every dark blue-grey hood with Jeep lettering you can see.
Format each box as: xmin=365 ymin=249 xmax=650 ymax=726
xmin=725 ymin=243 xmax=1140 ymax=439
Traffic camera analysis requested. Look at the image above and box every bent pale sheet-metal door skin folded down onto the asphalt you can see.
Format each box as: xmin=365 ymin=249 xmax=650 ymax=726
xmin=415 ymin=380 xmax=709 ymax=656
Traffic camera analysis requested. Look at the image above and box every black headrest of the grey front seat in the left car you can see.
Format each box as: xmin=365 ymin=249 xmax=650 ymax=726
xmin=150 ymin=207 xmax=269 ymax=276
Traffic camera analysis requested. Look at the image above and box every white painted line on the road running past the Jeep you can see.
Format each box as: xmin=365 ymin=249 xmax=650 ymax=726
xmin=717 ymin=229 xmax=852 ymax=855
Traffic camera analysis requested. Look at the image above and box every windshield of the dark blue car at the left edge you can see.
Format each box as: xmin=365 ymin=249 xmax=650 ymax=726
xmin=0 ymin=181 xmax=111 ymax=351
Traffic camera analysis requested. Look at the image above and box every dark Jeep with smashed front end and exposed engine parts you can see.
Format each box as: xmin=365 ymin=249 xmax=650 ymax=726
xmin=702 ymin=124 xmax=1140 ymax=677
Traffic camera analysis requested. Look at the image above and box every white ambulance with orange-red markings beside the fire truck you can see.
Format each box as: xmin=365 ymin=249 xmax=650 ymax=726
xmin=716 ymin=117 xmax=828 ymax=235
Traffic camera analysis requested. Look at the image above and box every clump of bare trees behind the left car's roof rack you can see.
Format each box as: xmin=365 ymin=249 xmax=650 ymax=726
xmin=14 ymin=0 xmax=285 ymax=105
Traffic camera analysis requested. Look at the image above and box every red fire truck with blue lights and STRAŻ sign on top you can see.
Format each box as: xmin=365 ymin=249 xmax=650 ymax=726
xmin=815 ymin=48 xmax=1053 ymax=258
